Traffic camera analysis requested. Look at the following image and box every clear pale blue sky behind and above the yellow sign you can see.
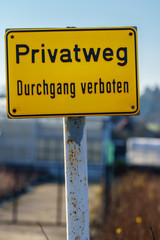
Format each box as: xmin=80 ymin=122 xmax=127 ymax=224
xmin=0 ymin=0 xmax=160 ymax=93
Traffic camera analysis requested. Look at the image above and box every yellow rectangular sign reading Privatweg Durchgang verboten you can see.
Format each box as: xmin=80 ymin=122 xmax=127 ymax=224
xmin=6 ymin=27 xmax=139 ymax=118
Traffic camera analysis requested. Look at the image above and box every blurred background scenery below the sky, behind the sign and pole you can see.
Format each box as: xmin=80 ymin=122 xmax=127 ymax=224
xmin=0 ymin=87 xmax=160 ymax=240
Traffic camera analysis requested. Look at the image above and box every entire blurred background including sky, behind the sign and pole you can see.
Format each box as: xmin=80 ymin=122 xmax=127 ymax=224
xmin=0 ymin=0 xmax=160 ymax=240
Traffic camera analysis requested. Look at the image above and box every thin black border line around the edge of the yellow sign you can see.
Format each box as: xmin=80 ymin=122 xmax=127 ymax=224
xmin=6 ymin=27 xmax=139 ymax=118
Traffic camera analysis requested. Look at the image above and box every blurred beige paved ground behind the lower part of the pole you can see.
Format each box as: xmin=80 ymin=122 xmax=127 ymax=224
xmin=0 ymin=183 xmax=101 ymax=240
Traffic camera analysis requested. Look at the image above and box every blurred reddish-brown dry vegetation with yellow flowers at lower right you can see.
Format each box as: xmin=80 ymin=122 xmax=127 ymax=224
xmin=94 ymin=171 xmax=160 ymax=240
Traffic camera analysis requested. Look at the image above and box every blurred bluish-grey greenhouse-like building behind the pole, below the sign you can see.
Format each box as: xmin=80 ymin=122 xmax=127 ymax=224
xmin=0 ymin=98 xmax=109 ymax=180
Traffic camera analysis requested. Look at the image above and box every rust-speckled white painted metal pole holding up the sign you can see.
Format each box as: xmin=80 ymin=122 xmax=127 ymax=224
xmin=63 ymin=117 xmax=89 ymax=240
